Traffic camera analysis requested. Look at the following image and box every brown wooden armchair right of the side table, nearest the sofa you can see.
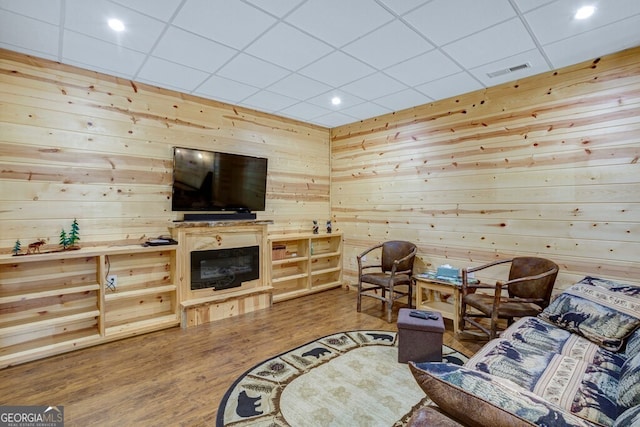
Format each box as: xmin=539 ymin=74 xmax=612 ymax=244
xmin=460 ymin=257 xmax=558 ymax=339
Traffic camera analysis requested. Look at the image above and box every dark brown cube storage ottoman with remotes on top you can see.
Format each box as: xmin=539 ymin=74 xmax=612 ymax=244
xmin=398 ymin=308 xmax=444 ymax=363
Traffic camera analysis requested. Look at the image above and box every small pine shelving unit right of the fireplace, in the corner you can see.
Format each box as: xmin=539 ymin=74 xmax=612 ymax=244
xmin=269 ymin=233 xmax=342 ymax=302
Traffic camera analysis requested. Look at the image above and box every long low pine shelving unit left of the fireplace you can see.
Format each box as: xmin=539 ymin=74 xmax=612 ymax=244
xmin=0 ymin=245 xmax=179 ymax=369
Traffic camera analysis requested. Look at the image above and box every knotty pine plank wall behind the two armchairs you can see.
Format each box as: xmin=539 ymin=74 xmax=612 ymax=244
xmin=331 ymin=48 xmax=640 ymax=289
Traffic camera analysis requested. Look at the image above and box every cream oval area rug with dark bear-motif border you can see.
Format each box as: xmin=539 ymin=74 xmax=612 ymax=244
xmin=216 ymin=331 xmax=467 ymax=427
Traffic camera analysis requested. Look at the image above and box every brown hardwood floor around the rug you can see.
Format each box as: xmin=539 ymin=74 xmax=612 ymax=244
xmin=0 ymin=289 xmax=484 ymax=426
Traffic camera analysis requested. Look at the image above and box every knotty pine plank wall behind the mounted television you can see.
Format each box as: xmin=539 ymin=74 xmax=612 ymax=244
xmin=0 ymin=50 xmax=330 ymax=253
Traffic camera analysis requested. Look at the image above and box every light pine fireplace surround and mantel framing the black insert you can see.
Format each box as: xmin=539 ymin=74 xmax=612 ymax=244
xmin=171 ymin=220 xmax=273 ymax=327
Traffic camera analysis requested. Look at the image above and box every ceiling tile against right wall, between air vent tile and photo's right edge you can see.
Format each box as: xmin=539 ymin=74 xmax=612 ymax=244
xmin=544 ymin=15 xmax=640 ymax=68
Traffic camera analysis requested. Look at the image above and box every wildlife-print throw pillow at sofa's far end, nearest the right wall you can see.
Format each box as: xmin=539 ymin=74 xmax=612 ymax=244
xmin=539 ymin=277 xmax=640 ymax=351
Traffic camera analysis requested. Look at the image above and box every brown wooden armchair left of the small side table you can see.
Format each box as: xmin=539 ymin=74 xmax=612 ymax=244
xmin=357 ymin=240 xmax=418 ymax=323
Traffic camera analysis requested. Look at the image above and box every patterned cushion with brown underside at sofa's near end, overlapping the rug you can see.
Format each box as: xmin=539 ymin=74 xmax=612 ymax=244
xmin=409 ymin=362 xmax=592 ymax=427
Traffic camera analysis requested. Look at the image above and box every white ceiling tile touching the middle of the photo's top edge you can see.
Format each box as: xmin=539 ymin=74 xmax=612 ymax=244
xmin=286 ymin=0 xmax=393 ymax=47
